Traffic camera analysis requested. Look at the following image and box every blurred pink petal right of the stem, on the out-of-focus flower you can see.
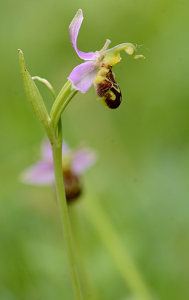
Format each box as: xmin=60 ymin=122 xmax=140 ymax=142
xmin=71 ymin=149 xmax=97 ymax=175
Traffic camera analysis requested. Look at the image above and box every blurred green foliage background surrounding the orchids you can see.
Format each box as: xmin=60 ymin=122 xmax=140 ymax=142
xmin=0 ymin=0 xmax=189 ymax=300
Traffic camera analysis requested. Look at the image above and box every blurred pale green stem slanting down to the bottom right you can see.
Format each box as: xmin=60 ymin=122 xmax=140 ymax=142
xmin=85 ymin=197 xmax=153 ymax=300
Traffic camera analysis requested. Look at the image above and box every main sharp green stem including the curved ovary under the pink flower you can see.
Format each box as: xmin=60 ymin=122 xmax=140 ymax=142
xmin=49 ymin=80 xmax=83 ymax=300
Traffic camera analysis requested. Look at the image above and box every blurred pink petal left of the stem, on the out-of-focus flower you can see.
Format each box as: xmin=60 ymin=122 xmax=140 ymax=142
xmin=21 ymin=160 xmax=54 ymax=185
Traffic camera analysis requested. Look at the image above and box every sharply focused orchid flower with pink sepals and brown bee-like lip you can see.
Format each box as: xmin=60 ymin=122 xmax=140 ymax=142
xmin=68 ymin=9 xmax=143 ymax=108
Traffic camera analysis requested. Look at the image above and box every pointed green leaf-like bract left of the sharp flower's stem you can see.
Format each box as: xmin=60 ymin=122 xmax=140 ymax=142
xmin=18 ymin=49 xmax=50 ymax=129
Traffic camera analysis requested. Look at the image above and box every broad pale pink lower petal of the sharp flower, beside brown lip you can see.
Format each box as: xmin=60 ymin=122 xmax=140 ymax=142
xmin=68 ymin=62 xmax=98 ymax=93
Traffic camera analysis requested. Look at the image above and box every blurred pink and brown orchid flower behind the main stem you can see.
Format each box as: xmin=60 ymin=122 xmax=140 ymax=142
xmin=21 ymin=140 xmax=97 ymax=200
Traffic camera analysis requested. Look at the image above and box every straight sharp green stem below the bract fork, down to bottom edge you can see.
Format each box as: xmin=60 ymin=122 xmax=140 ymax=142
xmin=52 ymin=143 xmax=83 ymax=300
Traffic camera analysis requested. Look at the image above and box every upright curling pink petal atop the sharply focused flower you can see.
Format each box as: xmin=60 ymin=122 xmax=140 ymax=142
xmin=69 ymin=9 xmax=95 ymax=60
